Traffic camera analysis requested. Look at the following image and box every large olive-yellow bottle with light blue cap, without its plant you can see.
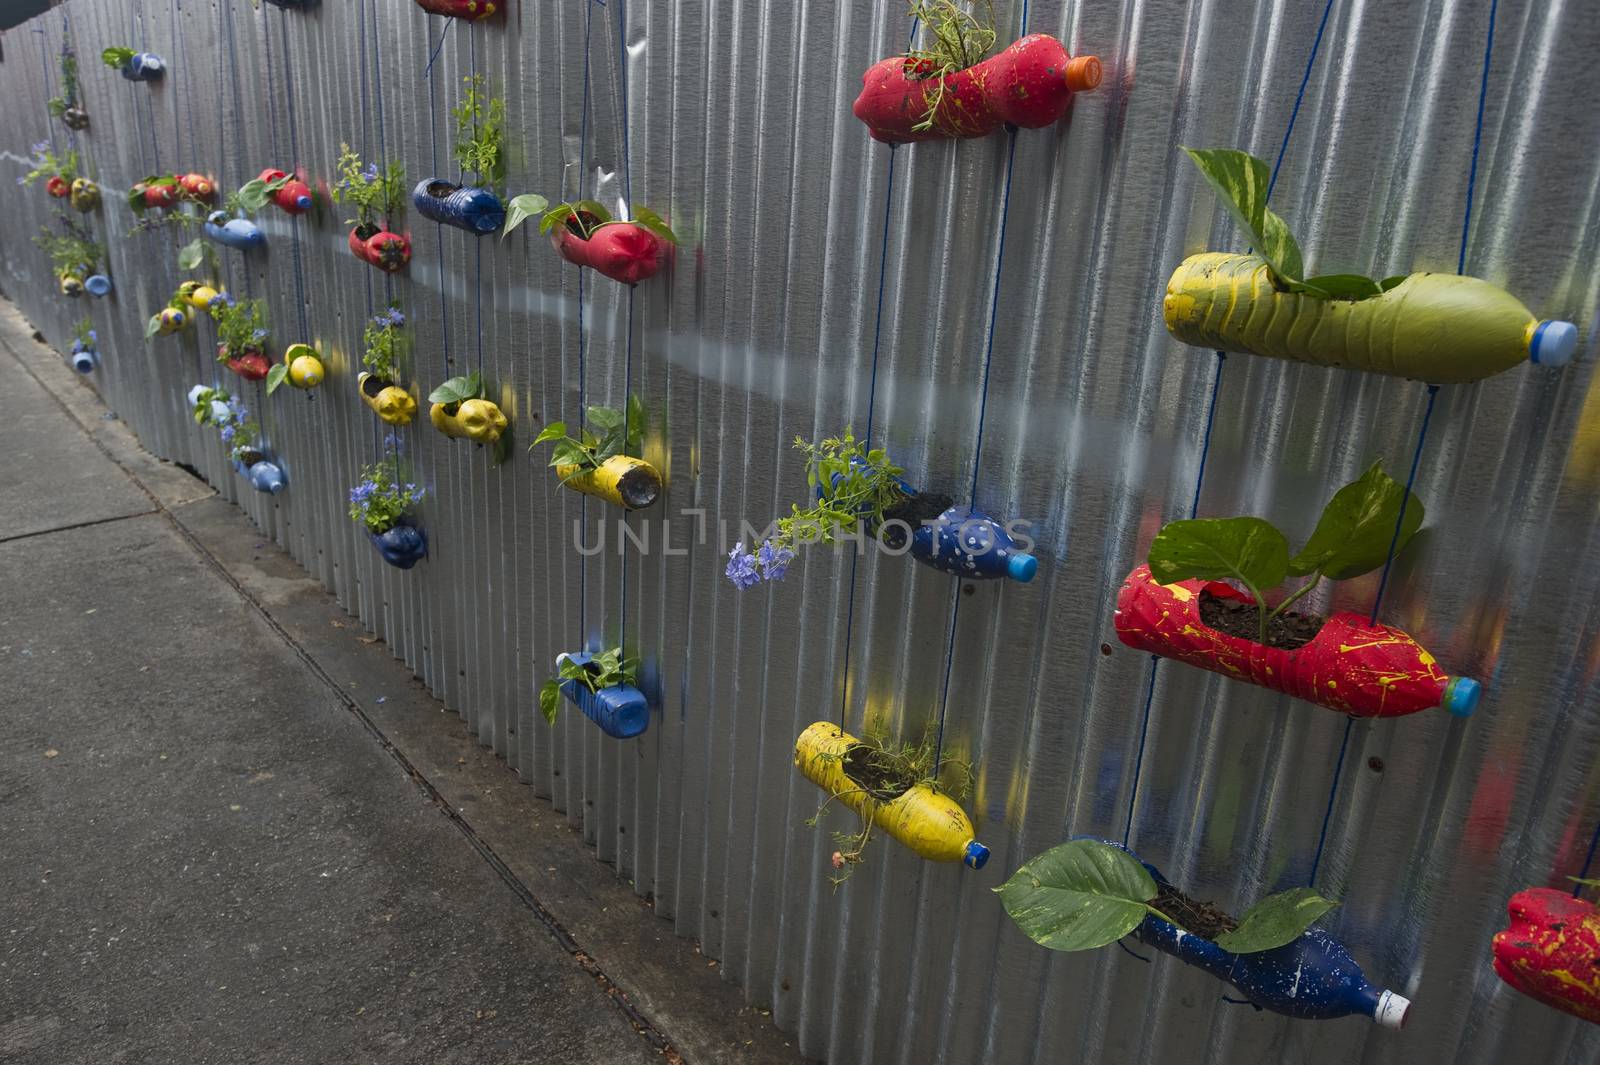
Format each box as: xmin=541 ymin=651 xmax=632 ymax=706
xmin=1162 ymin=251 xmax=1578 ymax=384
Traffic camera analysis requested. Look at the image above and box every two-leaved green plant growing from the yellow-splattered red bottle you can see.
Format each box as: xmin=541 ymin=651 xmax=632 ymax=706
xmin=1149 ymin=462 xmax=1422 ymax=643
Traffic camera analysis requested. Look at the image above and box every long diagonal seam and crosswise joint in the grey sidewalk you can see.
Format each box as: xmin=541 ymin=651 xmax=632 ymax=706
xmin=0 ymin=321 xmax=683 ymax=1065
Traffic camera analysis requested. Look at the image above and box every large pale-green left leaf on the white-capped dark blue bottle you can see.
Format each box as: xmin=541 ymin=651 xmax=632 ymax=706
xmin=995 ymin=840 xmax=1155 ymax=950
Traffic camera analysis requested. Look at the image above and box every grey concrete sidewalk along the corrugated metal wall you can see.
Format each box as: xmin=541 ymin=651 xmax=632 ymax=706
xmin=0 ymin=305 xmax=800 ymax=1065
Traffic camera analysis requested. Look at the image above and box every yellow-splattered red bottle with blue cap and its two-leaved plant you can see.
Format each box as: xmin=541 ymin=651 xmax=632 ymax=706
xmin=1115 ymin=462 xmax=1480 ymax=718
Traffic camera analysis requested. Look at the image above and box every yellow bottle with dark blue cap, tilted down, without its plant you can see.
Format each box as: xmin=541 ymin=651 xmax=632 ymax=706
xmin=795 ymin=721 xmax=989 ymax=868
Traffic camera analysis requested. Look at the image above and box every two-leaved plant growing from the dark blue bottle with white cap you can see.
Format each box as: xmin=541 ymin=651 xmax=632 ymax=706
xmin=994 ymin=840 xmax=1339 ymax=955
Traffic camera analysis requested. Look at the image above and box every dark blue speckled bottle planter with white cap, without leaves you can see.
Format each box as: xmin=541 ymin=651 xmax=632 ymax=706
xmin=1102 ymin=840 xmax=1411 ymax=1028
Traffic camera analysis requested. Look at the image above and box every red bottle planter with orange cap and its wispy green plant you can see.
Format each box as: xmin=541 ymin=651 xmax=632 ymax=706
xmin=851 ymin=0 xmax=1101 ymax=144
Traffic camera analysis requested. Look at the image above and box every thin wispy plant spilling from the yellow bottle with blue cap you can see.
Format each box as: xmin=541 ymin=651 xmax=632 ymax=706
xmin=805 ymin=723 xmax=973 ymax=889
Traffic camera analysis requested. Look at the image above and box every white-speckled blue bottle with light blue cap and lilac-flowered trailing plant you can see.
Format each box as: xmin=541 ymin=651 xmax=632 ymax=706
xmin=726 ymin=429 xmax=1038 ymax=588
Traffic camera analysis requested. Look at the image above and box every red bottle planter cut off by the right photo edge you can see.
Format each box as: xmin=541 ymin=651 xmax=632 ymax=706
xmin=1494 ymin=888 xmax=1600 ymax=1023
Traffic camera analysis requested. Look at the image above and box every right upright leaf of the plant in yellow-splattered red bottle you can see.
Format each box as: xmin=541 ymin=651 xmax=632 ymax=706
xmin=1288 ymin=462 xmax=1422 ymax=580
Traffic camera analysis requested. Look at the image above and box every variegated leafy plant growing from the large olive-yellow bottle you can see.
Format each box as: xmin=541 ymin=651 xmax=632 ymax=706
xmin=1182 ymin=147 xmax=1406 ymax=301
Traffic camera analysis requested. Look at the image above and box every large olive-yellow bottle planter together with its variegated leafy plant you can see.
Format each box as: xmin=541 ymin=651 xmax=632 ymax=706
xmin=1162 ymin=149 xmax=1578 ymax=384
